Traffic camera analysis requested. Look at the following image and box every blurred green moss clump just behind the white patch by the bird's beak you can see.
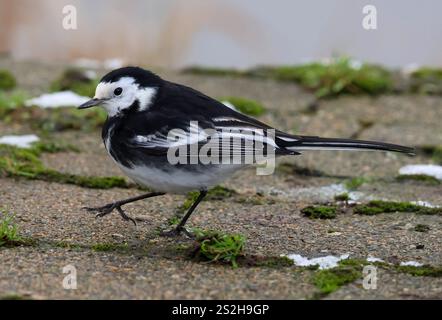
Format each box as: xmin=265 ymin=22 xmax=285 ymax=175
xmin=51 ymin=68 xmax=98 ymax=97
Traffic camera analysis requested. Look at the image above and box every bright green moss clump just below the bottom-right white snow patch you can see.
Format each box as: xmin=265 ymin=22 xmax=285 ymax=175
xmin=312 ymin=265 xmax=362 ymax=294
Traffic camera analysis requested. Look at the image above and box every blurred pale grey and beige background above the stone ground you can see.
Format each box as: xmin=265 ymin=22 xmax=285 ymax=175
xmin=0 ymin=0 xmax=442 ymax=68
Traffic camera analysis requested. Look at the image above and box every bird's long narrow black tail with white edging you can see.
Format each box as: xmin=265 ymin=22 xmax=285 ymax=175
xmin=280 ymin=136 xmax=415 ymax=155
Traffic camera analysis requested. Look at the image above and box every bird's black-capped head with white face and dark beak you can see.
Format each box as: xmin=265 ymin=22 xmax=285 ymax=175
xmin=78 ymin=67 xmax=163 ymax=117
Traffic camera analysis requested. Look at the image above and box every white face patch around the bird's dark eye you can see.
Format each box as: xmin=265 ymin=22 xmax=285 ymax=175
xmin=94 ymin=77 xmax=158 ymax=117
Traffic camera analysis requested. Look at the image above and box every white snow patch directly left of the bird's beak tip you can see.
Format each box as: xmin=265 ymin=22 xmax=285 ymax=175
xmin=25 ymin=91 xmax=89 ymax=108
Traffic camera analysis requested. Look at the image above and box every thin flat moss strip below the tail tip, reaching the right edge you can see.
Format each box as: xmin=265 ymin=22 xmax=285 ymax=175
xmin=354 ymin=200 xmax=442 ymax=216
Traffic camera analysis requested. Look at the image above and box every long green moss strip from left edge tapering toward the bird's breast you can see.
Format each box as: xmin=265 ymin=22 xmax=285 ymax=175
xmin=0 ymin=145 xmax=128 ymax=189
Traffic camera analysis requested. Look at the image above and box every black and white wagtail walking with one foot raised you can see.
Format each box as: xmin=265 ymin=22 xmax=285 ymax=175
xmin=78 ymin=66 xmax=415 ymax=236
